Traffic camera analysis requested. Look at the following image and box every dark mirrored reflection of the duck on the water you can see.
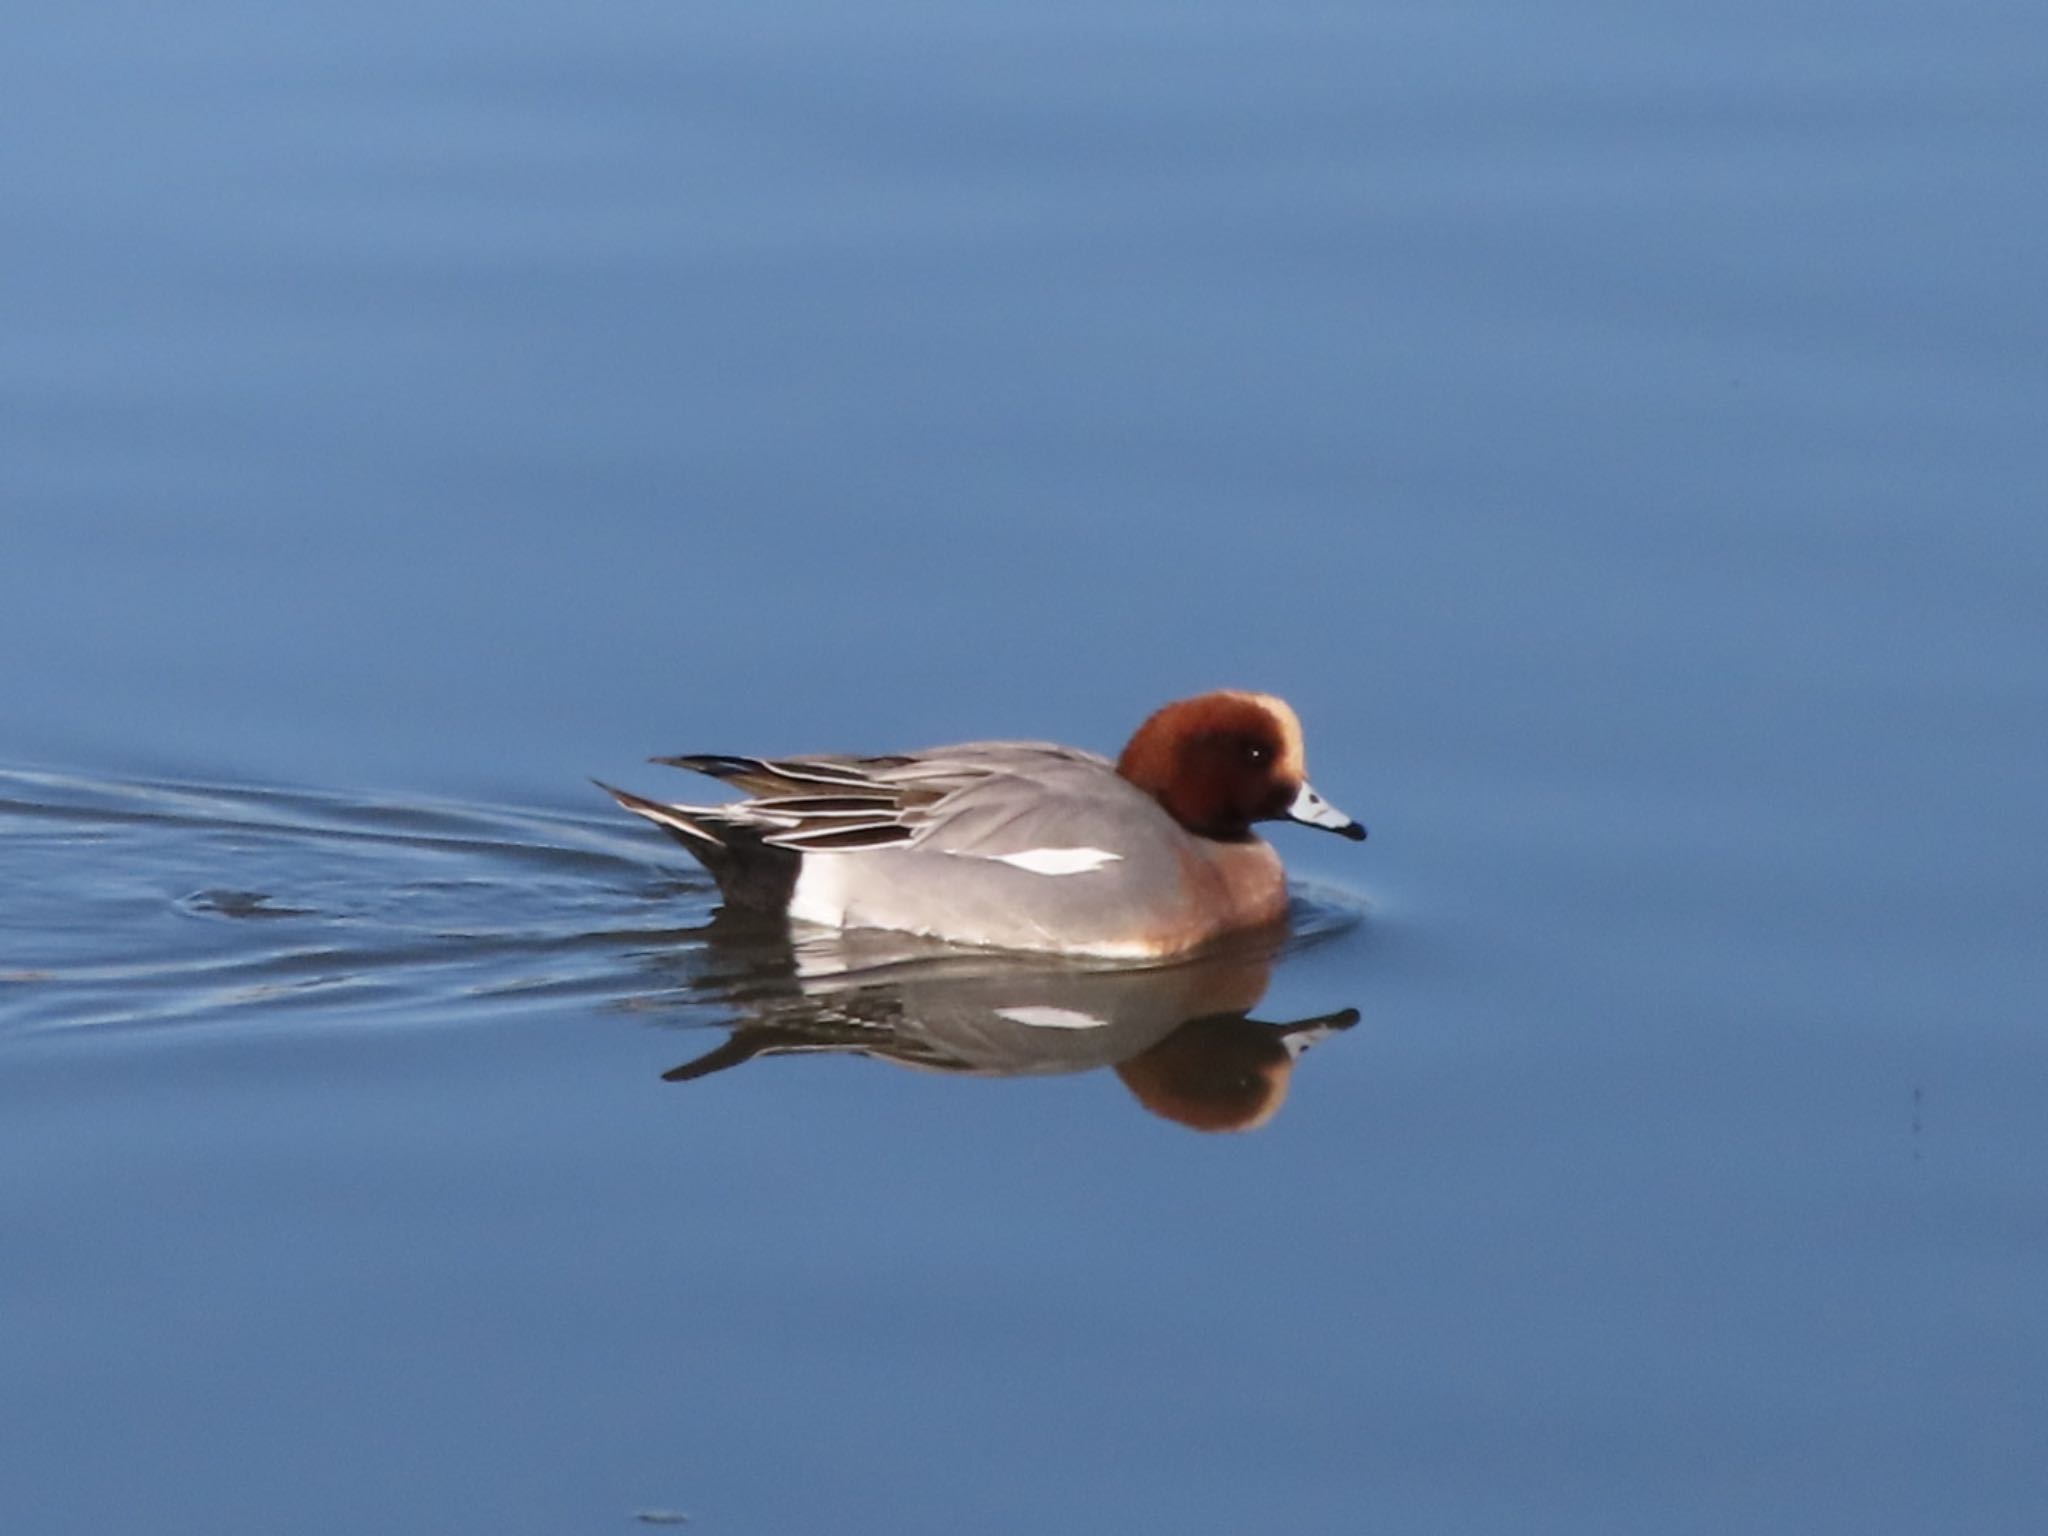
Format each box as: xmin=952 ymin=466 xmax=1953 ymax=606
xmin=664 ymin=920 xmax=1358 ymax=1130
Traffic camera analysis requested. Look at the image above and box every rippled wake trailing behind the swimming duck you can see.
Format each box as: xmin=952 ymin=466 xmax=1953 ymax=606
xmin=0 ymin=772 xmax=713 ymax=1028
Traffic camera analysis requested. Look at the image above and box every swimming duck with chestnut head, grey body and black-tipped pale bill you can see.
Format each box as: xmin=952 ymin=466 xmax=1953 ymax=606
xmin=602 ymin=692 xmax=1366 ymax=958
